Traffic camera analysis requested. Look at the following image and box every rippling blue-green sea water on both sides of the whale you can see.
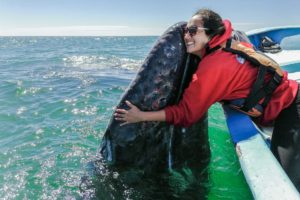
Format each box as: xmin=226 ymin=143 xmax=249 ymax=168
xmin=0 ymin=36 xmax=300 ymax=199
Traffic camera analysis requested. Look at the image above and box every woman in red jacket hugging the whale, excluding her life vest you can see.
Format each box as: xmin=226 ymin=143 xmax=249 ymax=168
xmin=114 ymin=9 xmax=300 ymax=191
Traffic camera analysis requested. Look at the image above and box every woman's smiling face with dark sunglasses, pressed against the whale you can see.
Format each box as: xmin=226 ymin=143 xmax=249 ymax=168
xmin=184 ymin=15 xmax=209 ymax=57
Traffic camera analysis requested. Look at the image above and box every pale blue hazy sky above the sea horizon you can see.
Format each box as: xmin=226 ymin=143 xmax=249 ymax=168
xmin=0 ymin=0 xmax=300 ymax=36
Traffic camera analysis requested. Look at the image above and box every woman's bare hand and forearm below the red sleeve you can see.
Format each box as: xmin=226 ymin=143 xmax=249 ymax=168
xmin=114 ymin=101 xmax=166 ymax=126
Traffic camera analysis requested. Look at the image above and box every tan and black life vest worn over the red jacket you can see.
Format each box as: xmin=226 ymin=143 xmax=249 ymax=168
xmin=206 ymin=37 xmax=283 ymax=117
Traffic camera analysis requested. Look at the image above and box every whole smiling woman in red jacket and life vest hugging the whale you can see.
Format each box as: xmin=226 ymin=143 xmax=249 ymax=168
xmin=115 ymin=9 xmax=300 ymax=194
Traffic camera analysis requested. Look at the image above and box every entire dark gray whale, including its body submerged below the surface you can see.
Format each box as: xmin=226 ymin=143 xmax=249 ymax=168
xmin=79 ymin=22 xmax=210 ymax=200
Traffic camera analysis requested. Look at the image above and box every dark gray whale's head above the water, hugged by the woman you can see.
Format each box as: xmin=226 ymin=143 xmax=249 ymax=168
xmin=100 ymin=22 xmax=210 ymax=174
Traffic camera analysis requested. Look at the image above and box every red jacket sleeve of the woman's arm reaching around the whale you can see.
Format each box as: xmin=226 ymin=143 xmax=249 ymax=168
xmin=164 ymin=57 xmax=230 ymax=127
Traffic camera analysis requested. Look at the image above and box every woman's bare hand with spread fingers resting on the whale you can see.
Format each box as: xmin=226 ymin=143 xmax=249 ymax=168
xmin=114 ymin=101 xmax=143 ymax=126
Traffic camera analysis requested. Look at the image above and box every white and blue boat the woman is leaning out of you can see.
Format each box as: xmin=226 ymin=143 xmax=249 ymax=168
xmin=224 ymin=27 xmax=300 ymax=200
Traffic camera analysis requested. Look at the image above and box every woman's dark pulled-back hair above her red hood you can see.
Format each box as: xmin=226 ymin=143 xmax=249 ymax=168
xmin=193 ymin=9 xmax=225 ymax=38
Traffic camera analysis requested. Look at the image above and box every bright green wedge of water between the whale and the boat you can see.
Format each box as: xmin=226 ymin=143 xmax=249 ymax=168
xmin=208 ymin=104 xmax=253 ymax=200
